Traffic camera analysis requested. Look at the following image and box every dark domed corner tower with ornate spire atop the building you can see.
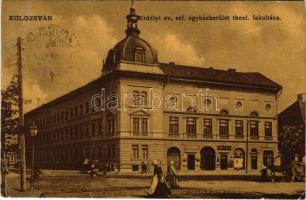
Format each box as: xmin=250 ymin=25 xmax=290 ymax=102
xmin=102 ymin=6 xmax=158 ymax=73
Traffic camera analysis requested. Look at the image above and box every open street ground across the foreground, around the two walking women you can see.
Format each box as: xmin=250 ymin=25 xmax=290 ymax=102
xmin=8 ymin=170 xmax=305 ymax=199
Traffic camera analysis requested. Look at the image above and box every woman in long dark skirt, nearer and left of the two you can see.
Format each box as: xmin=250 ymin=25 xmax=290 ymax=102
xmin=149 ymin=160 xmax=171 ymax=198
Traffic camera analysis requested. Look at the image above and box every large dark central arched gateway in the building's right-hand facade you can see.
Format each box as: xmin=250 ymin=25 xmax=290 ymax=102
xmin=200 ymin=147 xmax=216 ymax=170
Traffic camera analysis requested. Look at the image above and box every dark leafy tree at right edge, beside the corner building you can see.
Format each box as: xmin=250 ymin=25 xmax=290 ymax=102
xmin=279 ymin=124 xmax=305 ymax=167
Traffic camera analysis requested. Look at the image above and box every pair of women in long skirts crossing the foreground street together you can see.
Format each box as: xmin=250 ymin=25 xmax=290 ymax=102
xmin=148 ymin=160 xmax=179 ymax=198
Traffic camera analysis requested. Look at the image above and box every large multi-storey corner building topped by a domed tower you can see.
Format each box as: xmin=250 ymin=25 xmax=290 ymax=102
xmin=25 ymin=5 xmax=282 ymax=173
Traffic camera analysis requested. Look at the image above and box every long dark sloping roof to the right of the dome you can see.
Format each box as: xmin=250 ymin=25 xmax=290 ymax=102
xmin=160 ymin=63 xmax=282 ymax=90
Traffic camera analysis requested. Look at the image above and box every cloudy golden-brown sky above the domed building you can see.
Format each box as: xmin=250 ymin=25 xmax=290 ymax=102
xmin=1 ymin=0 xmax=306 ymax=111
